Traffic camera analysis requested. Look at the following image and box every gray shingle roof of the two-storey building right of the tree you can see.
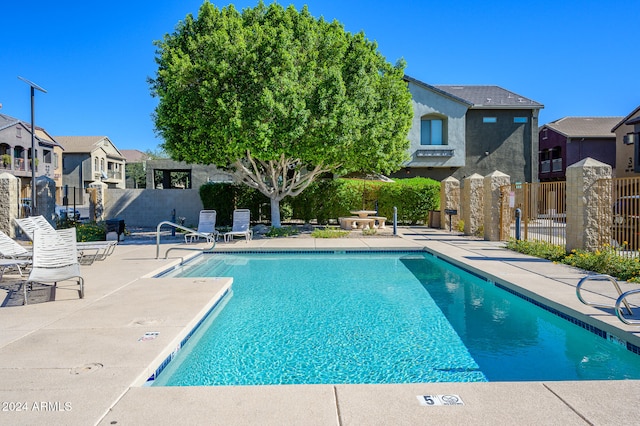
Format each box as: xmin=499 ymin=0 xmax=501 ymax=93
xmin=434 ymin=85 xmax=544 ymax=109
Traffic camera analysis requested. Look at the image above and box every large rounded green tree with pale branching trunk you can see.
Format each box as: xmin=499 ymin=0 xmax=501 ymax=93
xmin=149 ymin=1 xmax=413 ymax=227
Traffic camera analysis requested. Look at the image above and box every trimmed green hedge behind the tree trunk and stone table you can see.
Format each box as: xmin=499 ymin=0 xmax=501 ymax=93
xmin=200 ymin=178 xmax=440 ymax=226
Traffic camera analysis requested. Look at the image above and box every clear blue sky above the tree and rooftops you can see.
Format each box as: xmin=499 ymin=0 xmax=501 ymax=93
xmin=0 ymin=0 xmax=640 ymax=151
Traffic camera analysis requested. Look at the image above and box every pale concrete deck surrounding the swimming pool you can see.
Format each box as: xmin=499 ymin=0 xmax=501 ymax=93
xmin=0 ymin=227 xmax=640 ymax=425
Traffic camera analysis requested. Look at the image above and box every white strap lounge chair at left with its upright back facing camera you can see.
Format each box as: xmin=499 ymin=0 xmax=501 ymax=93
xmin=24 ymin=228 xmax=84 ymax=305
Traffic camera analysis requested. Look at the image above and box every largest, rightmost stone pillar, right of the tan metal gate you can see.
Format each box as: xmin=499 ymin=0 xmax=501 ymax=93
xmin=566 ymin=157 xmax=613 ymax=251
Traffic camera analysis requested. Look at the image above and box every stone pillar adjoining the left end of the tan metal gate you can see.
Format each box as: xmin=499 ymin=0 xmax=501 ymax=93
xmin=483 ymin=170 xmax=511 ymax=241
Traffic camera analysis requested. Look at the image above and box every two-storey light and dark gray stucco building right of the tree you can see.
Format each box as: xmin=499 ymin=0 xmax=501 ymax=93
xmin=392 ymin=76 xmax=544 ymax=182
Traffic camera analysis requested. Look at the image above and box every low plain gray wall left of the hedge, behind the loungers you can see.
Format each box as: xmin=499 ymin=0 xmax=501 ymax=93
xmin=104 ymin=188 xmax=202 ymax=227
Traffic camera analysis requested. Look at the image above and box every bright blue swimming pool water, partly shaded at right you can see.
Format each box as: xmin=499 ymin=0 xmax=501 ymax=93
xmin=153 ymin=253 xmax=640 ymax=386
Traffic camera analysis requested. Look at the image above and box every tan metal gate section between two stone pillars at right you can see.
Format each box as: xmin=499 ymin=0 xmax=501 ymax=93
xmin=500 ymin=182 xmax=567 ymax=246
